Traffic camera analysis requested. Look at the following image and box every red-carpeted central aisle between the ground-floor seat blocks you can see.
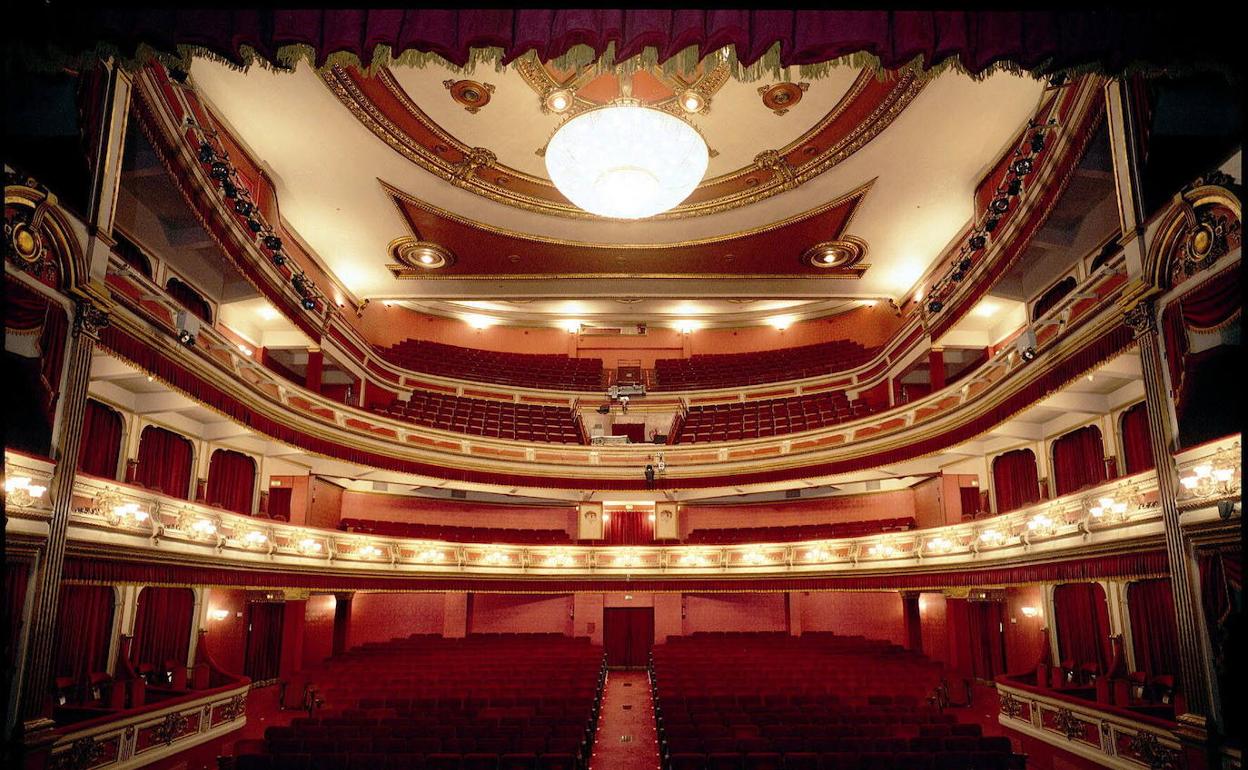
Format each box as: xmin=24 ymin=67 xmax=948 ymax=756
xmin=589 ymin=671 xmax=659 ymax=770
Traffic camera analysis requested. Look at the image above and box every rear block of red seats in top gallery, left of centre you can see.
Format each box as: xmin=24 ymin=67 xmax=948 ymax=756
xmin=382 ymin=339 xmax=603 ymax=391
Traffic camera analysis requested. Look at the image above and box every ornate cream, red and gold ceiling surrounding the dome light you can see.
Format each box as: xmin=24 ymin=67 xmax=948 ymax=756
xmin=184 ymin=57 xmax=1043 ymax=323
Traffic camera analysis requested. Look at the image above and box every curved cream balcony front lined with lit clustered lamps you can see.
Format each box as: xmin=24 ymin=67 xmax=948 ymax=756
xmin=5 ymin=436 xmax=1241 ymax=578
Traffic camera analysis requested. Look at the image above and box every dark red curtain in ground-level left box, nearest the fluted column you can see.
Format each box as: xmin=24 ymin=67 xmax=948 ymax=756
xmin=52 ymin=585 xmax=114 ymax=681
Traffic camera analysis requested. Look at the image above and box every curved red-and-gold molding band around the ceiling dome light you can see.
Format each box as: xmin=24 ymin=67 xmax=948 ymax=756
xmin=322 ymin=66 xmax=926 ymax=220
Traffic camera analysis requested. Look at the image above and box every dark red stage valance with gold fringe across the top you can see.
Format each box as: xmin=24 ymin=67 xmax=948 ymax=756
xmin=19 ymin=6 xmax=1233 ymax=72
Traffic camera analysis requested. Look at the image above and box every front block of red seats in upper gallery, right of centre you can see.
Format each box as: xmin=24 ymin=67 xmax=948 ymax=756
xmin=674 ymin=392 xmax=877 ymax=444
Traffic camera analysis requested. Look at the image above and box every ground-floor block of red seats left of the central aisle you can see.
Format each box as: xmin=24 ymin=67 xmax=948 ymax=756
xmin=236 ymin=634 xmax=605 ymax=770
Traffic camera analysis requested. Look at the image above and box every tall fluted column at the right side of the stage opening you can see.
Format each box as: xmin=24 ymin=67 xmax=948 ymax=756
xmin=1124 ymin=300 xmax=1213 ymax=738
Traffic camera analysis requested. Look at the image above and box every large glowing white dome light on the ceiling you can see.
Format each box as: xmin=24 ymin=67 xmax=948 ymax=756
xmin=545 ymin=100 xmax=710 ymax=220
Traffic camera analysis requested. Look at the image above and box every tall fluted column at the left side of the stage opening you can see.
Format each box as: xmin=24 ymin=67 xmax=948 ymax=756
xmin=20 ymin=302 xmax=109 ymax=734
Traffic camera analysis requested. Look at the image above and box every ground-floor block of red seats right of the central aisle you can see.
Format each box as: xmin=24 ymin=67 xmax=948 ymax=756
xmin=650 ymin=633 xmax=1022 ymax=770
